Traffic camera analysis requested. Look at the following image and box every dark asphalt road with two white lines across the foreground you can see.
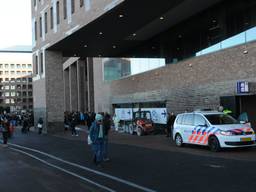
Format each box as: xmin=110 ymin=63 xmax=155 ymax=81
xmin=0 ymin=129 xmax=256 ymax=192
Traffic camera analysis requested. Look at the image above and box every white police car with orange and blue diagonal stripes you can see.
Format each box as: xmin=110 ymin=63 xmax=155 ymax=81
xmin=173 ymin=111 xmax=256 ymax=151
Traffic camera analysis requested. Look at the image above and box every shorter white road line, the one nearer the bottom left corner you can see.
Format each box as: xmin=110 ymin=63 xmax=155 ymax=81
xmin=10 ymin=147 xmax=116 ymax=192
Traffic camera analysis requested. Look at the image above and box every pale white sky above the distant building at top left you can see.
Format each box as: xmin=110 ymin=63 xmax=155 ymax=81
xmin=0 ymin=0 xmax=32 ymax=49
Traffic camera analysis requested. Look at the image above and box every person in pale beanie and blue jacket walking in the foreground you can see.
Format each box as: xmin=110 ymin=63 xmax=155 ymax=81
xmin=89 ymin=114 xmax=104 ymax=166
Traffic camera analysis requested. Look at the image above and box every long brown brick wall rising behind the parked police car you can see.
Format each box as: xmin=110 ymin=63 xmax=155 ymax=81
xmin=111 ymin=42 xmax=256 ymax=113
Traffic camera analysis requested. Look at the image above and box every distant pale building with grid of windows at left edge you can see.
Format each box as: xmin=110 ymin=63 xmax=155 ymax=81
xmin=0 ymin=51 xmax=33 ymax=112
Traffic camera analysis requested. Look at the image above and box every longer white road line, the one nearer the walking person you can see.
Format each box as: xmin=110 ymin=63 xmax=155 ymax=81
xmin=9 ymin=143 xmax=156 ymax=192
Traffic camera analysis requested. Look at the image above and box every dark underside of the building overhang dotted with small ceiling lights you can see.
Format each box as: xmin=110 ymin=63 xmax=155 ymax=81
xmin=48 ymin=0 xmax=221 ymax=57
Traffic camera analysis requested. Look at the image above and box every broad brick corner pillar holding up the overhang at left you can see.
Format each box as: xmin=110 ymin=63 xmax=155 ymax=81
xmin=38 ymin=50 xmax=64 ymax=133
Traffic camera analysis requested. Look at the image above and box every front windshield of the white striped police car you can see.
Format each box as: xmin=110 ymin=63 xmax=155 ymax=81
xmin=205 ymin=114 xmax=239 ymax=125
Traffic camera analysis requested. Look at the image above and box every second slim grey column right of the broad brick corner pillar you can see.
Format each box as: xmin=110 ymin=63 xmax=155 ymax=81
xmin=69 ymin=62 xmax=78 ymax=111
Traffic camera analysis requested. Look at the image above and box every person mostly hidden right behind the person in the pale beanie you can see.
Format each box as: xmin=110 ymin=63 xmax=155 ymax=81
xmin=103 ymin=113 xmax=111 ymax=161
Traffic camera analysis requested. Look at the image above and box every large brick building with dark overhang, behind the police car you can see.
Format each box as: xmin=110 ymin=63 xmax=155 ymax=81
xmin=32 ymin=0 xmax=256 ymax=131
